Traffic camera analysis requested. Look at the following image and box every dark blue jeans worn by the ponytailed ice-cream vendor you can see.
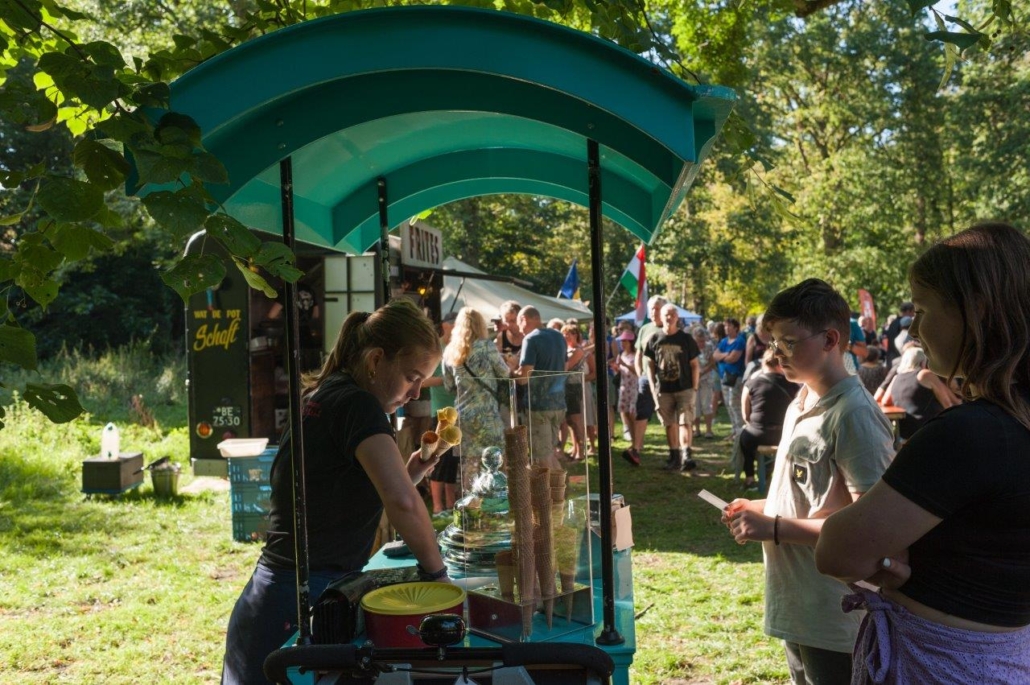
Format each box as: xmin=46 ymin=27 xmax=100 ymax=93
xmin=221 ymin=561 xmax=347 ymax=685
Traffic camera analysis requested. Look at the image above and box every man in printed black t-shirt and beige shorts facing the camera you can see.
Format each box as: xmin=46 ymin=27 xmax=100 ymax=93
xmin=644 ymin=304 xmax=700 ymax=471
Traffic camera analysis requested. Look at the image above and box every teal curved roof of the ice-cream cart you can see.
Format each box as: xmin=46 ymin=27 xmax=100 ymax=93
xmin=149 ymin=6 xmax=735 ymax=251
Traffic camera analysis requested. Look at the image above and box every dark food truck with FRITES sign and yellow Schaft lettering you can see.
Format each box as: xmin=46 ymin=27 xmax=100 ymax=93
xmin=185 ymin=219 xmax=535 ymax=478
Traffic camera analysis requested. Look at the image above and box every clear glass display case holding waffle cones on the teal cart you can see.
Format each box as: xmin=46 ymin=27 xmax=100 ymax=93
xmin=440 ymin=372 xmax=593 ymax=642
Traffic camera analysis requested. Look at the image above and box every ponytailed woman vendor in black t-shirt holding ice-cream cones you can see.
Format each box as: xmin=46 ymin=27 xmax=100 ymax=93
xmin=221 ymin=300 xmax=447 ymax=685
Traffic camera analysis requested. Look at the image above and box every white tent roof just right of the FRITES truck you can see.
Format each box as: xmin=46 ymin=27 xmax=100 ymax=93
xmin=440 ymin=256 xmax=593 ymax=323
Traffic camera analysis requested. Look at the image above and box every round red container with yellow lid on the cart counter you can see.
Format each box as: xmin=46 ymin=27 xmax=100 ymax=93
xmin=362 ymin=582 xmax=465 ymax=648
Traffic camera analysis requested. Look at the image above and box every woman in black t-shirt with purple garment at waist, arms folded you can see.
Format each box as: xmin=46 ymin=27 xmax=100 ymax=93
xmin=817 ymin=224 xmax=1030 ymax=683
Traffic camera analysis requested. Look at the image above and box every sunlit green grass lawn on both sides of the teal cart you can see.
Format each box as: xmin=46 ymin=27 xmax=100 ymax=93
xmin=0 ymin=350 xmax=787 ymax=684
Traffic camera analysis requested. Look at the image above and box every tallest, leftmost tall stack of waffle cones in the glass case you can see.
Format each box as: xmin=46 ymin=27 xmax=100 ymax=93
xmin=505 ymin=425 xmax=537 ymax=638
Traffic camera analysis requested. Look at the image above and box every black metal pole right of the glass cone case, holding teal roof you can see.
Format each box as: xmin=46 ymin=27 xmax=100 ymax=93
xmin=586 ymin=135 xmax=625 ymax=645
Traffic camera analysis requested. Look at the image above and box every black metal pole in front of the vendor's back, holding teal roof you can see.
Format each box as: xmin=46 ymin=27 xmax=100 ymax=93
xmin=279 ymin=157 xmax=311 ymax=645
